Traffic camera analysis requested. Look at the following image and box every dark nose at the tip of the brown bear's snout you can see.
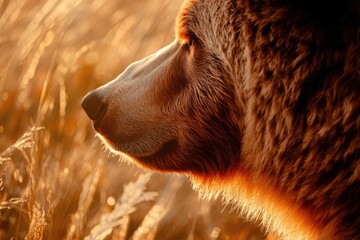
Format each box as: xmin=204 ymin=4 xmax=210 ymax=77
xmin=81 ymin=91 xmax=107 ymax=121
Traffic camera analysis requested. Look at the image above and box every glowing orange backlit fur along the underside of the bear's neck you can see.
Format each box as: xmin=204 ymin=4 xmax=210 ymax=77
xmin=192 ymin=172 xmax=321 ymax=239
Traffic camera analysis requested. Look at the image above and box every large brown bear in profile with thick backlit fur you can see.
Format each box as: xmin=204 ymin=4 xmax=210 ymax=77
xmin=82 ymin=0 xmax=360 ymax=239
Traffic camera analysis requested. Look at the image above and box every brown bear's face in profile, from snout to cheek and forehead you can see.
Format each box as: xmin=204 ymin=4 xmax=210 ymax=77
xmin=82 ymin=1 xmax=244 ymax=176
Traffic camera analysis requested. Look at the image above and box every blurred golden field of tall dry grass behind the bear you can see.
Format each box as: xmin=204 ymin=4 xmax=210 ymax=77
xmin=0 ymin=0 xmax=264 ymax=240
